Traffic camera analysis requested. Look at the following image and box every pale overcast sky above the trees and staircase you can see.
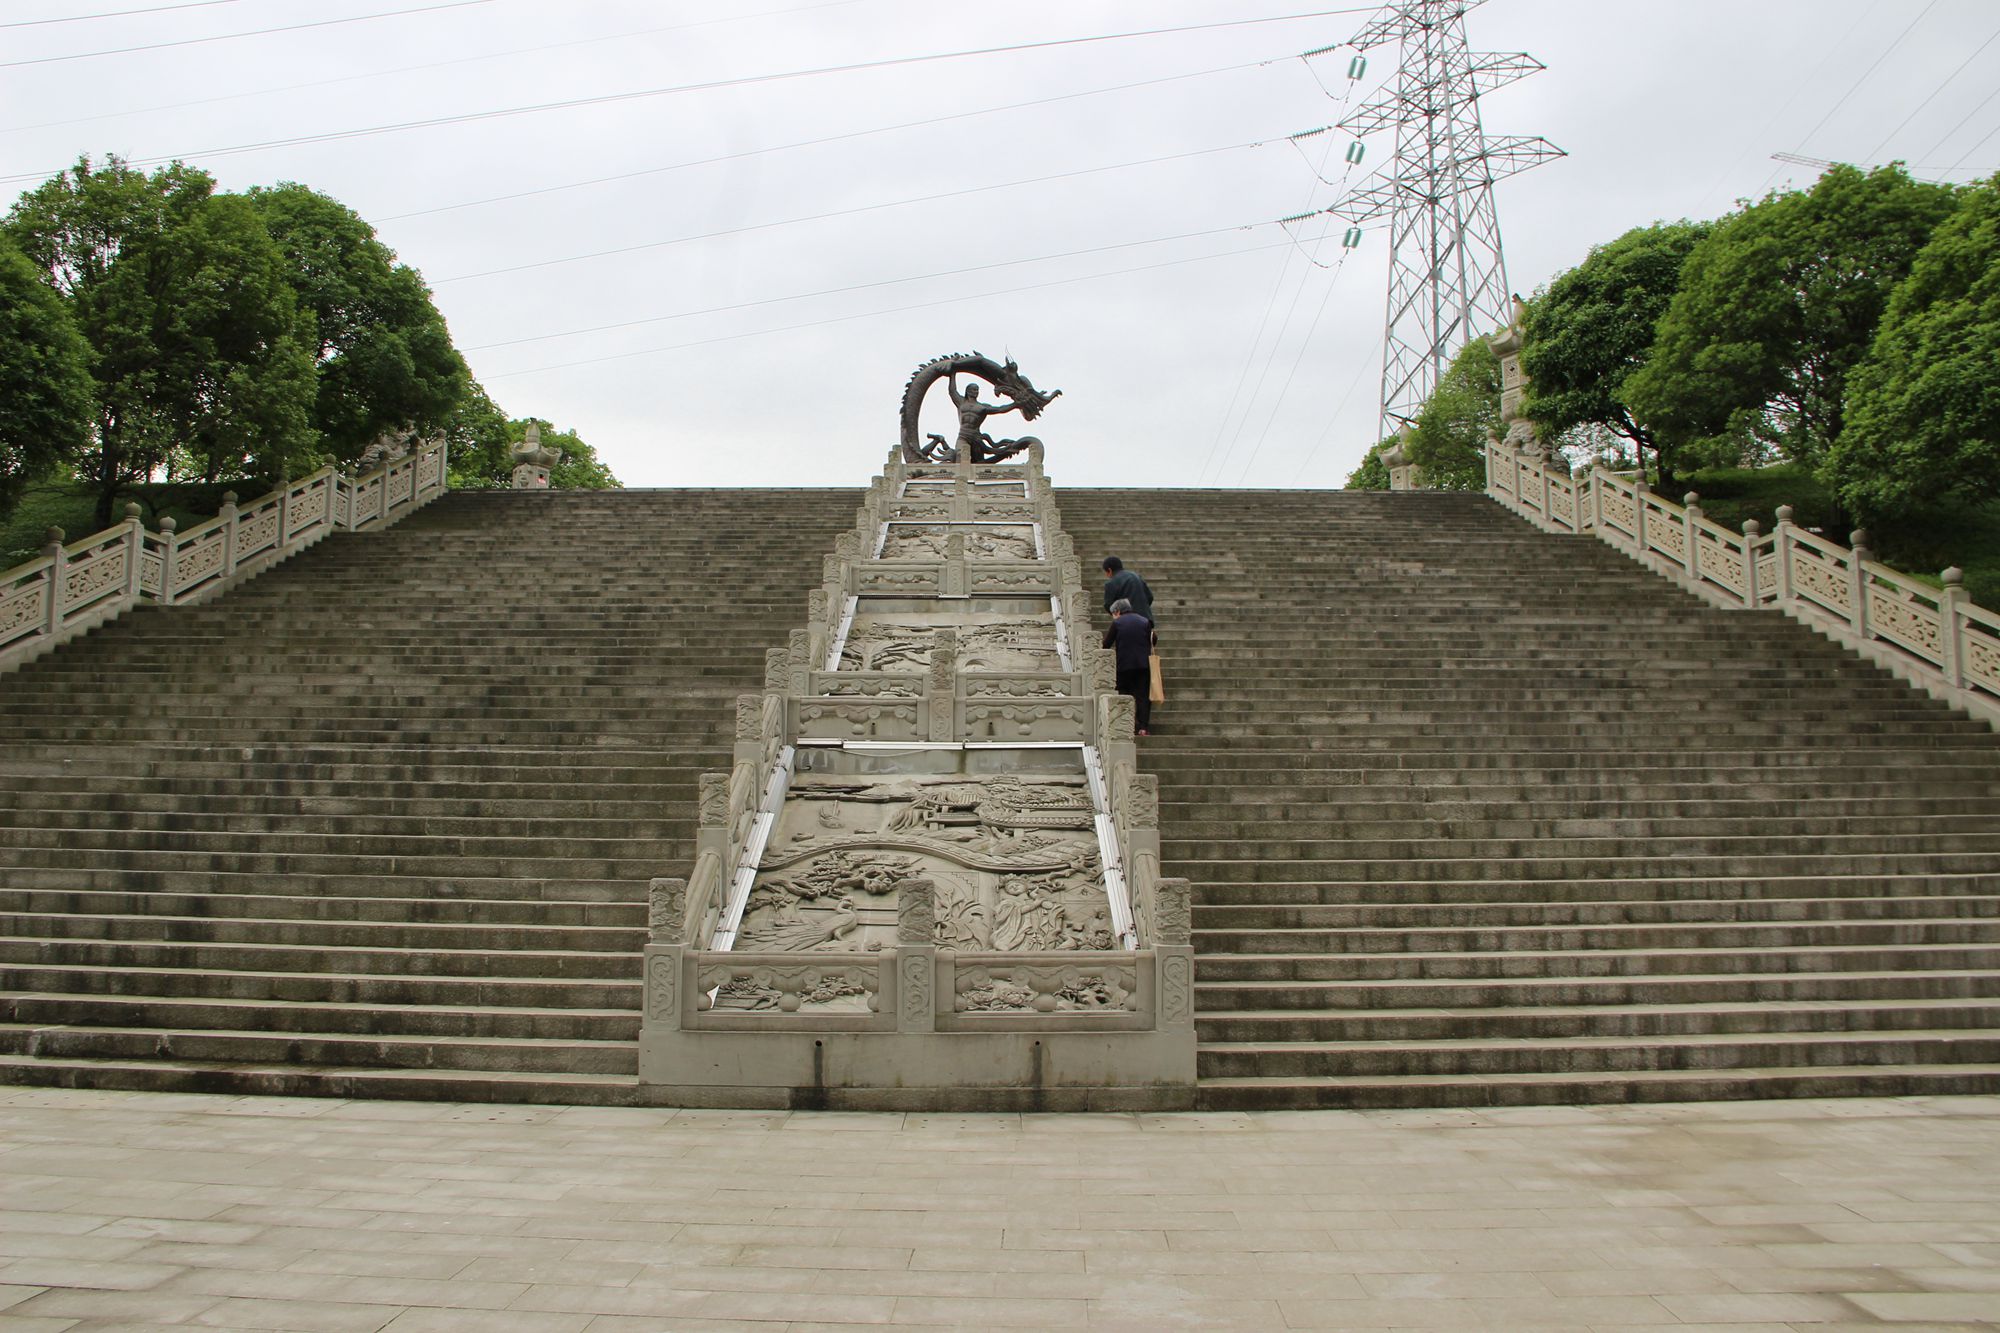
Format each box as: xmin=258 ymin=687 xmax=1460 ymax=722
xmin=0 ymin=0 xmax=2000 ymax=486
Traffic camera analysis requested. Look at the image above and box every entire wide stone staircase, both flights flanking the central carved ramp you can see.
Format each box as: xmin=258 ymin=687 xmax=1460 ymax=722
xmin=0 ymin=490 xmax=2000 ymax=1107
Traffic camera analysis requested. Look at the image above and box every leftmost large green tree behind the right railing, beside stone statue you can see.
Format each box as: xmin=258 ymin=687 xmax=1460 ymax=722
xmin=1522 ymin=222 xmax=1708 ymax=486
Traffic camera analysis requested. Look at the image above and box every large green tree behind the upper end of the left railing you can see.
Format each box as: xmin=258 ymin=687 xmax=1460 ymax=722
xmin=250 ymin=182 xmax=472 ymax=462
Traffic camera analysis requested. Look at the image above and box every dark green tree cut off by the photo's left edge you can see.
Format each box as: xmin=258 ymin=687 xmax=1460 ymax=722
xmin=0 ymin=234 xmax=92 ymax=518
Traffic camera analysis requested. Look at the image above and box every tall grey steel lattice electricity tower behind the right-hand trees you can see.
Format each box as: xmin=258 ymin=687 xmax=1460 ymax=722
xmin=1326 ymin=0 xmax=1564 ymax=436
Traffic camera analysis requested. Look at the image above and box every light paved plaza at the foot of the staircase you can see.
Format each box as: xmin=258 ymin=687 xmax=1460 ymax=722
xmin=0 ymin=1089 xmax=2000 ymax=1333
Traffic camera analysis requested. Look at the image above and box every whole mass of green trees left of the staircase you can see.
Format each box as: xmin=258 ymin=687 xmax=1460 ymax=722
xmin=0 ymin=156 xmax=618 ymax=526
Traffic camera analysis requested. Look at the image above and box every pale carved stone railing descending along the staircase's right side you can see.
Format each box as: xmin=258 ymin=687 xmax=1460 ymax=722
xmin=1486 ymin=442 xmax=2000 ymax=727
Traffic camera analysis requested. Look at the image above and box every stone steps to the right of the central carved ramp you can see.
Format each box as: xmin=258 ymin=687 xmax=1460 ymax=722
xmin=1058 ymin=490 xmax=2000 ymax=1109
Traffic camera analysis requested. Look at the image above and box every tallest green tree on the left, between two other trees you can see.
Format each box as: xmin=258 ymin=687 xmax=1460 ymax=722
xmin=4 ymin=158 xmax=316 ymax=526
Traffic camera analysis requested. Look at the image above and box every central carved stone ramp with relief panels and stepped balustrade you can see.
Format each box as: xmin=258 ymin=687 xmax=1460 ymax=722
xmin=640 ymin=448 xmax=1194 ymax=1109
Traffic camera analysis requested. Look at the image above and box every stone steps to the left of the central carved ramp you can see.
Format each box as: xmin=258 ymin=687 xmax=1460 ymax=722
xmin=0 ymin=490 xmax=858 ymax=1103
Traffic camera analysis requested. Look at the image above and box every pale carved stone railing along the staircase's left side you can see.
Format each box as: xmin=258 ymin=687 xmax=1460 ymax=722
xmin=0 ymin=440 xmax=446 ymax=671
